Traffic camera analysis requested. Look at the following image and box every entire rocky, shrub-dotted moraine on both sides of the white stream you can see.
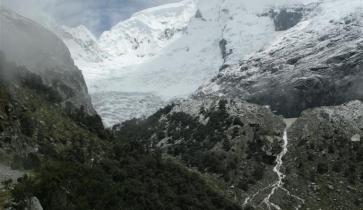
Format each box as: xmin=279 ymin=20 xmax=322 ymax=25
xmin=113 ymin=98 xmax=363 ymax=209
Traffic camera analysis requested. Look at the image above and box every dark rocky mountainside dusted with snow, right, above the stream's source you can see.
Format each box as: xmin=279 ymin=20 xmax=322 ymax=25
xmin=199 ymin=4 xmax=363 ymax=117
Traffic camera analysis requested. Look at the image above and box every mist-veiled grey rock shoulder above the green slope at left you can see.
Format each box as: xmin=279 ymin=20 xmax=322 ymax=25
xmin=0 ymin=7 xmax=95 ymax=114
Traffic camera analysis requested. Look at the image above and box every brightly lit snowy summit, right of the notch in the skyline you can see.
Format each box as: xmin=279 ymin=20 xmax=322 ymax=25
xmin=99 ymin=0 xmax=196 ymax=64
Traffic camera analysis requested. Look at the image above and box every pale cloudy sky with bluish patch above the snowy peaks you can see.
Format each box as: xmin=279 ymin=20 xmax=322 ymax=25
xmin=0 ymin=0 xmax=179 ymax=35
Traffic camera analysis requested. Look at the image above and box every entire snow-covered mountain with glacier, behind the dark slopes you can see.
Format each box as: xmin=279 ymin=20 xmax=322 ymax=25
xmin=62 ymin=0 xmax=360 ymax=125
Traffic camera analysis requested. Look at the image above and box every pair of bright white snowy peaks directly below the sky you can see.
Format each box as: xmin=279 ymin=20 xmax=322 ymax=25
xmin=64 ymin=0 xmax=196 ymax=81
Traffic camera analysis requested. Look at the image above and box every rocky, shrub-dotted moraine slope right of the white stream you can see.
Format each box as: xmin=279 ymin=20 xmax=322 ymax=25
xmin=282 ymin=101 xmax=363 ymax=210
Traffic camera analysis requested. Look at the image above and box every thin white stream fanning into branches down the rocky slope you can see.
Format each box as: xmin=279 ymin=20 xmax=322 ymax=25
xmin=243 ymin=119 xmax=305 ymax=210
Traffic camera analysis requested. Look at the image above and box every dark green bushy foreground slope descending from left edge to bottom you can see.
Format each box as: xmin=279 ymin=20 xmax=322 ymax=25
xmin=0 ymin=56 xmax=240 ymax=210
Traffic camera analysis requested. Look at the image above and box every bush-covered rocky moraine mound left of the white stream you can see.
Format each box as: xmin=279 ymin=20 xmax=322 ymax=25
xmin=114 ymin=98 xmax=285 ymax=205
